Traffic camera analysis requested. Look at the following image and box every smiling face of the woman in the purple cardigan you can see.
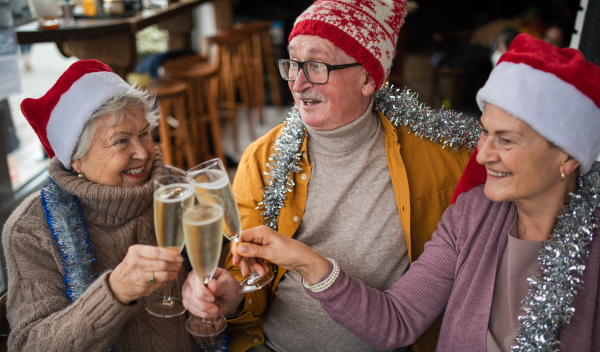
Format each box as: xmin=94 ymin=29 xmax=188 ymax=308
xmin=477 ymin=103 xmax=573 ymax=206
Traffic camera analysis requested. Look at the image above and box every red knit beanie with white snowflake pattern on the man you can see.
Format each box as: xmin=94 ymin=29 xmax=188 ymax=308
xmin=288 ymin=0 xmax=407 ymax=87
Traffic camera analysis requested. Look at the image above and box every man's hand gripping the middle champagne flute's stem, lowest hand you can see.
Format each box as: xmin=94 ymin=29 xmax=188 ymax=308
xmin=183 ymin=268 xmax=244 ymax=318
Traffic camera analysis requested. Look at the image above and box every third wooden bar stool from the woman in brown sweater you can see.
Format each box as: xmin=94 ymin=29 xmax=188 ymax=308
xmin=204 ymin=31 xmax=256 ymax=150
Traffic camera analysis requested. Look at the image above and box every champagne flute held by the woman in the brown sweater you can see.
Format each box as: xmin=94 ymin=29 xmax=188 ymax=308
xmin=146 ymin=175 xmax=194 ymax=318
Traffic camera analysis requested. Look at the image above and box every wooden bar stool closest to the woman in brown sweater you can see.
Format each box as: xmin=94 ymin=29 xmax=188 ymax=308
xmin=147 ymin=79 xmax=198 ymax=170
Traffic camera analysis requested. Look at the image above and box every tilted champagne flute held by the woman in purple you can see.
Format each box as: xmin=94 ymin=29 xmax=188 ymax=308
xmin=187 ymin=158 xmax=274 ymax=293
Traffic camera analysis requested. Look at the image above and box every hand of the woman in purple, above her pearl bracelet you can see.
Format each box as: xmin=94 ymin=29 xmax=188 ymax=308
xmin=231 ymin=225 xmax=329 ymax=285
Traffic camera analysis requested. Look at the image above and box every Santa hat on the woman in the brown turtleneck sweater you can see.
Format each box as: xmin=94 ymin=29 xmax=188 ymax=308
xmin=21 ymin=60 xmax=130 ymax=170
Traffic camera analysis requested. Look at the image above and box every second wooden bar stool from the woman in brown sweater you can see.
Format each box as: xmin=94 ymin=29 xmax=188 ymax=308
xmin=161 ymin=55 xmax=225 ymax=162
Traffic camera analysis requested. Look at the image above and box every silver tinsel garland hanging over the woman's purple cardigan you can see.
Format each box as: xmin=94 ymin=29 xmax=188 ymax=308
xmin=511 ymin=163 xmax=600 ymax=352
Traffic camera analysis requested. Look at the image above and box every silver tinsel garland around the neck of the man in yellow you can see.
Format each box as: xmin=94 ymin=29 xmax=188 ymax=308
xmin=257 ymin=84 xmax=479 ymax=230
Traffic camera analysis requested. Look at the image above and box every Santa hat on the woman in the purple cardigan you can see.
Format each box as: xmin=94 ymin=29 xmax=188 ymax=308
xmin=477 ymin=33 xmax=600 ymax=174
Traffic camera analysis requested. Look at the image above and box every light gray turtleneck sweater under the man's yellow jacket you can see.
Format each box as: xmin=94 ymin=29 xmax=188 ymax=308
xmin=264 ymin=100 xmax=409 ymax=352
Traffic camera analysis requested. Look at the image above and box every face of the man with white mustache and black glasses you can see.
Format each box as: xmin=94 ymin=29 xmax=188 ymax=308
xmin=288 ymin=35 xmax=375 ymax=130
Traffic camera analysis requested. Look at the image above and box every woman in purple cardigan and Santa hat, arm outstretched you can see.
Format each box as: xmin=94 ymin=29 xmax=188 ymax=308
xmin=232 ymin=34 xmax=600 ymax=351
